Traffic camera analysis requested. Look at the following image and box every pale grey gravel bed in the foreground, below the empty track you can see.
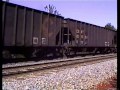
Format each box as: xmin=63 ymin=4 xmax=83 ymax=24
xmin=2 ymin=59 xmax=117 ymax=90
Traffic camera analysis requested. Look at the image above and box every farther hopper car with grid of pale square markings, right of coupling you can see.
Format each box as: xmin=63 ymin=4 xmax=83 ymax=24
xmin=62 ymin=18 xmax=117 ymax=54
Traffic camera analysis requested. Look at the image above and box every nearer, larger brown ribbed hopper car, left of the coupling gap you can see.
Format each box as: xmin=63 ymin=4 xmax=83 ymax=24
xmin=2 ymin=1 xmax=64 ymax=58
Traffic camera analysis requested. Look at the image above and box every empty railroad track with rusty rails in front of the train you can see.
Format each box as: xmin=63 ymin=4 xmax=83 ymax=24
xmin=2 ymin=54 xmax=117 ymax=77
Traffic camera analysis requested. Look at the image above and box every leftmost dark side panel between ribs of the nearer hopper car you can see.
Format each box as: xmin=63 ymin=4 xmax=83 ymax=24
xmin=4 ymin=4 xmax=17 ymax=46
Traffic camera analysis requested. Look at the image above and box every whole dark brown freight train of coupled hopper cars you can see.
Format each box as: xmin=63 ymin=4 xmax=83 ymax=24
xmin=2 ymin=1 xmax=117 ymax=58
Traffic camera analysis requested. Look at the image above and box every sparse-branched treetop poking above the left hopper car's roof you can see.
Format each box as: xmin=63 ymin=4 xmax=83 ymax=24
xmin=44 ymin=4 xmax=61 ymax=16
